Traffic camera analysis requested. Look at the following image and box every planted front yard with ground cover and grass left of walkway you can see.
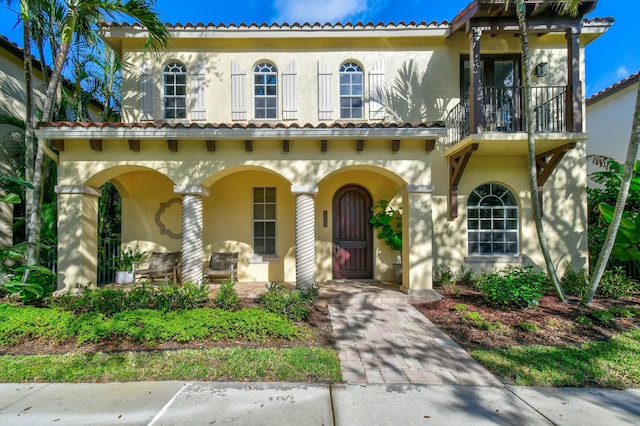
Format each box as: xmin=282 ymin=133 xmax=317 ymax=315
xmin=0 ymin=283 xmax=341 ymax=382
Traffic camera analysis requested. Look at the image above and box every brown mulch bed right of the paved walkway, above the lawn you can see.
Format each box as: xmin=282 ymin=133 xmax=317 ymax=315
xmin=416 ymin=285 xmax=640 ymax=350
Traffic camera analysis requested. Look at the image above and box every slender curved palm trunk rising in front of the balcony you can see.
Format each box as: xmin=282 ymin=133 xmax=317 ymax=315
xmin=516 ymin=0 xmax=567 ymax=302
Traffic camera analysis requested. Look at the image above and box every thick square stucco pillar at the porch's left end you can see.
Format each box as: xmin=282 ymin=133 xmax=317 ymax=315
xmin=55 ymin=185 xmax=101 ymax=290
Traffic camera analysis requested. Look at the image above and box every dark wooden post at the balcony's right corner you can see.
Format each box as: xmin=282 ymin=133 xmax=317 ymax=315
xmin=566 ymin=26 xmax=583 ymax=132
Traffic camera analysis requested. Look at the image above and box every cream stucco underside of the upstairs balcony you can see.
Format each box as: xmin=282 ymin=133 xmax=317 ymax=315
xmin=444 ymin=132 xmax=589 ymax=157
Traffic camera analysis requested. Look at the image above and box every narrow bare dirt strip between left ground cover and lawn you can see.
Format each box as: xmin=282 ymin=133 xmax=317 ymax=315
xmin=0 ymin=299 xmax=334 ymax=355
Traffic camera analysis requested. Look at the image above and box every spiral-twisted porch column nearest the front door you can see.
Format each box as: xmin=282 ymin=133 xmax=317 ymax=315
xmin=291 ymin=185 xmax=318 ymax=289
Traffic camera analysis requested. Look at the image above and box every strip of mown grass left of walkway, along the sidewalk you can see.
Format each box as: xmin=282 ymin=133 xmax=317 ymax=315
xmin=0 ymin=347 xmax=342 ymax=383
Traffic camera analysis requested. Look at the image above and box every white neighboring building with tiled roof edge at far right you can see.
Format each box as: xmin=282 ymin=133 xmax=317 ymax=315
xmin=587 ymin=71 xmax=640 ymax=178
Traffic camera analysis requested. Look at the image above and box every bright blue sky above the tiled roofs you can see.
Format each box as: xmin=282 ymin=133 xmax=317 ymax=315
xmin=0 ymin=0 xmax=640 ymax=96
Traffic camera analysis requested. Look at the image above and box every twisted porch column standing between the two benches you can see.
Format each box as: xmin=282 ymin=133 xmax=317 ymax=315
xmin=173 ymin=185 xmax=209 ymax=283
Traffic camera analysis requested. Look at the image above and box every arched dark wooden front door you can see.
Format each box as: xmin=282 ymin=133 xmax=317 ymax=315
xmin=333 ymin=185 xmax=373 ymax=279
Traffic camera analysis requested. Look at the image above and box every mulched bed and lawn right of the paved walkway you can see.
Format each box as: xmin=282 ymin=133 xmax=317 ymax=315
xmin=416 ymin=271 xmax=640 ymax=388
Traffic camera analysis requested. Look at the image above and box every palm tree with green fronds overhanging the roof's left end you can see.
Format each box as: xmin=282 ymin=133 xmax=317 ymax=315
xmin=21 ymin=0 xmax=169 ymax=265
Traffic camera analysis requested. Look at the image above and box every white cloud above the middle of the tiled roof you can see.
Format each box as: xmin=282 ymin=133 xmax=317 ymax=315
xmin=274 ymin=0 xmax=367 ymax=24
